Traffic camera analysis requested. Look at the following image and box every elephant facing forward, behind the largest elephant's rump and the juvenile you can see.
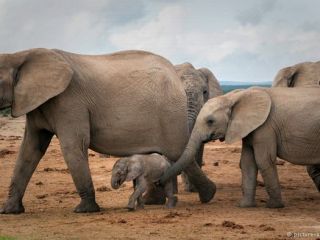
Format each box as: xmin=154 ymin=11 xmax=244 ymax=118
xmin=174 ymin=62 xmax=223 ymax=192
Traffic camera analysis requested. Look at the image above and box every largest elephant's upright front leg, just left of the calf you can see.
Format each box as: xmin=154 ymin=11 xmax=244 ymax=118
xmin=59 ymin=129 xmax=100 ymax=213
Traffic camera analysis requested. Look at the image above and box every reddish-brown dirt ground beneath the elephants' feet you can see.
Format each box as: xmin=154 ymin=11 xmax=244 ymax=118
xmin=0 ymin=118 xmax=320 ymax=240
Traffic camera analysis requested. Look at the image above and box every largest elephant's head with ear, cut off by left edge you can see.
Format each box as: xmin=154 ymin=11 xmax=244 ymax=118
xmin=0 ymin=49 xmax=73 ymax=117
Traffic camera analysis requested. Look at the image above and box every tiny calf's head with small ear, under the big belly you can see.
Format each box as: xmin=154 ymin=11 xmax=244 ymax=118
xmin=111 ymin=157 xmax=143 ymax=189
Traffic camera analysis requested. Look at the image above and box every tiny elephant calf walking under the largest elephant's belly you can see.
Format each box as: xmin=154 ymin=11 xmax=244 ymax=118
xmin=111 ymin=153 xmax=177 ymax=211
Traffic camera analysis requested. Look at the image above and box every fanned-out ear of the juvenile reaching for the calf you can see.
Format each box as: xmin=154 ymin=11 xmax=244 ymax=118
xmin=225 ymin=89 xmax=271 ymax=144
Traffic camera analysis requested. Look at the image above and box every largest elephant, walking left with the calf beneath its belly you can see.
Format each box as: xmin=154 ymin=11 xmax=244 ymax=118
xmin=0 ymin=49 xmax=215 ymax=213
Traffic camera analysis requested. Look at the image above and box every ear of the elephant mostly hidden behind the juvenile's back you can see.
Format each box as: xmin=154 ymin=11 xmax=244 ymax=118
xmin=272 ymin=67 xmax=298 ymax=87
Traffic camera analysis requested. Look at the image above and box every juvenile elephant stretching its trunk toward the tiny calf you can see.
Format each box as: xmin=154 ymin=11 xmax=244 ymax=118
xmin=160 ymin=88 xmax=320 ymax=208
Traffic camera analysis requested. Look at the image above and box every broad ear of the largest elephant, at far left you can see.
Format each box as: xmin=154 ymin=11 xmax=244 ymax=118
xmin=12 ymin=49 xmax=73 ymax=117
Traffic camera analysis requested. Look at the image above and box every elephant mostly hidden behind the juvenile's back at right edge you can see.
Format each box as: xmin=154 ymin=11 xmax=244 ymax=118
xmin=272 ymin=61 xmax=320 ymax=192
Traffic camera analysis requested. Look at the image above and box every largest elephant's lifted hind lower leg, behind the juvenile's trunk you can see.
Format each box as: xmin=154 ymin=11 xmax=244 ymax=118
xmin=184 ymin=161 xmax=216 ymax=203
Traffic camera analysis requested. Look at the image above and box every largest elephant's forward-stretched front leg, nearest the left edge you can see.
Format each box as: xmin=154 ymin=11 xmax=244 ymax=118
xmin=0 ymin=123 xmax=53 ymax=214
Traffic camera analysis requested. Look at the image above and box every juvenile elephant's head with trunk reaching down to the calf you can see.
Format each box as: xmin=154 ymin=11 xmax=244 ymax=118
xmin=160 ymin=89 xmax=271 ymax=184
